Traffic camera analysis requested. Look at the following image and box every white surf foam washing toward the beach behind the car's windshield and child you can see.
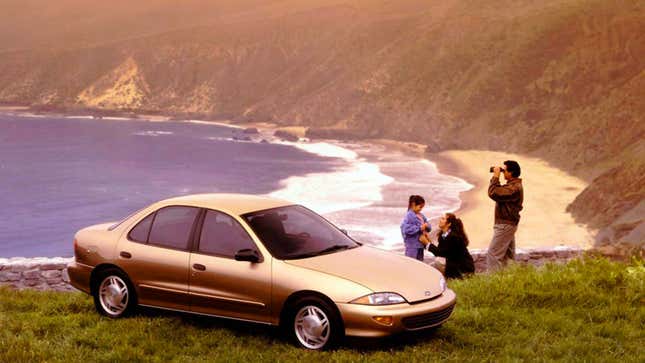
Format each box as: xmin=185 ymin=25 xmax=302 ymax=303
xmin=269 ymin=141 xmax=473 ymax=250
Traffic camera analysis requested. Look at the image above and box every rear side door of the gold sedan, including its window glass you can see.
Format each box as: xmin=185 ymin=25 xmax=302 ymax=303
xmin=118 ymin=206 xmax=200 ymax=310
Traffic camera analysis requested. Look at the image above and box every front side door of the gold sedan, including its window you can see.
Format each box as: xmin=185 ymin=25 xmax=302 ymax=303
xmin=189 ymin=210 xmax=271 ymax=322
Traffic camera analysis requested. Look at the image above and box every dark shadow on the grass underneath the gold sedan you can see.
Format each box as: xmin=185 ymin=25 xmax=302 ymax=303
xmin=137 ymin=307 xmax=445 ymax=353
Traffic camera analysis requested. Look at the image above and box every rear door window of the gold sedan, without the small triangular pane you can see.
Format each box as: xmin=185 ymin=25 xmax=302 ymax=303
xmin=148 ymin=206 xmax=199 ymax=250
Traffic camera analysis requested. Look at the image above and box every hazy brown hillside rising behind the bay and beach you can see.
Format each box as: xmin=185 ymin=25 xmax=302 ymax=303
xmin=0 ymin=0 xmax=645 ymax=250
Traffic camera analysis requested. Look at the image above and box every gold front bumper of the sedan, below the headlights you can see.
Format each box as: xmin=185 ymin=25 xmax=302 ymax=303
xmin=336 ymin=289 xmax=457 ymax=337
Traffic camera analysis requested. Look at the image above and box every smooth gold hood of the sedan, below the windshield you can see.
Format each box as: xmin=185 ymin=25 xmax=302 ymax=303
xmin=285 ymin=246 xmax=443 ymax=302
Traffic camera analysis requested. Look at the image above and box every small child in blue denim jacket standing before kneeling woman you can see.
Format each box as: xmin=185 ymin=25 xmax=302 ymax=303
xmin=401 ymin=195 xmax=431 ymax=261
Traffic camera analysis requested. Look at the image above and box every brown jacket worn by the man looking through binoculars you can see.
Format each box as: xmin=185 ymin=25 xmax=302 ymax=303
xmin=488 ymin=177 xmax=524 ymax=226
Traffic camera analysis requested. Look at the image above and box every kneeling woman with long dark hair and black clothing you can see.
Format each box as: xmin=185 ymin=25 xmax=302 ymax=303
xmin=428 ymin=213 xmax=475 ymax=278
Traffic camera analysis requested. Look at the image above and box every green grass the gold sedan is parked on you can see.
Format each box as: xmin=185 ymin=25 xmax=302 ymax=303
xmin=0 ymin=258 xmax=645 ymax=362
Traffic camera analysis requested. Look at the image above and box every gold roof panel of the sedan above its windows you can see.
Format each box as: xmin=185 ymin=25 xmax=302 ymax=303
xmin=159 ymin=193 xmax=294 ymax=215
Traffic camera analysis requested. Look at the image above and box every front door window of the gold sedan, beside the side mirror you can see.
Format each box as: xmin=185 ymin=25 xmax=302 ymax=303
xmin=199 ymin=210 xmax=256 ymax=258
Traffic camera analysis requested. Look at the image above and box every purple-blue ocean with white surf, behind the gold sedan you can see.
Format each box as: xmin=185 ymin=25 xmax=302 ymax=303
xmin=0 ymin=114 xmax=472 ymax=257
